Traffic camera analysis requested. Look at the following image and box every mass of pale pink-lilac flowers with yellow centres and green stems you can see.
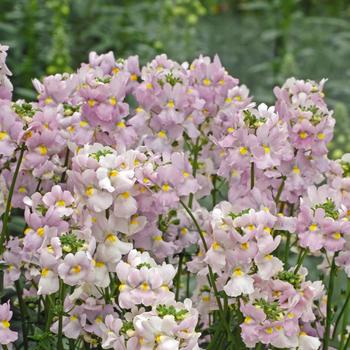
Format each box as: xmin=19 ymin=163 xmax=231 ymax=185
xmin=0 ymin=46 xmax=350 ymax=350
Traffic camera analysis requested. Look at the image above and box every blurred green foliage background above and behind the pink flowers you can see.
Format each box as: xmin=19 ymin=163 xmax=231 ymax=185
xmin=0 ymin=0 xmax=350 ymax=157
